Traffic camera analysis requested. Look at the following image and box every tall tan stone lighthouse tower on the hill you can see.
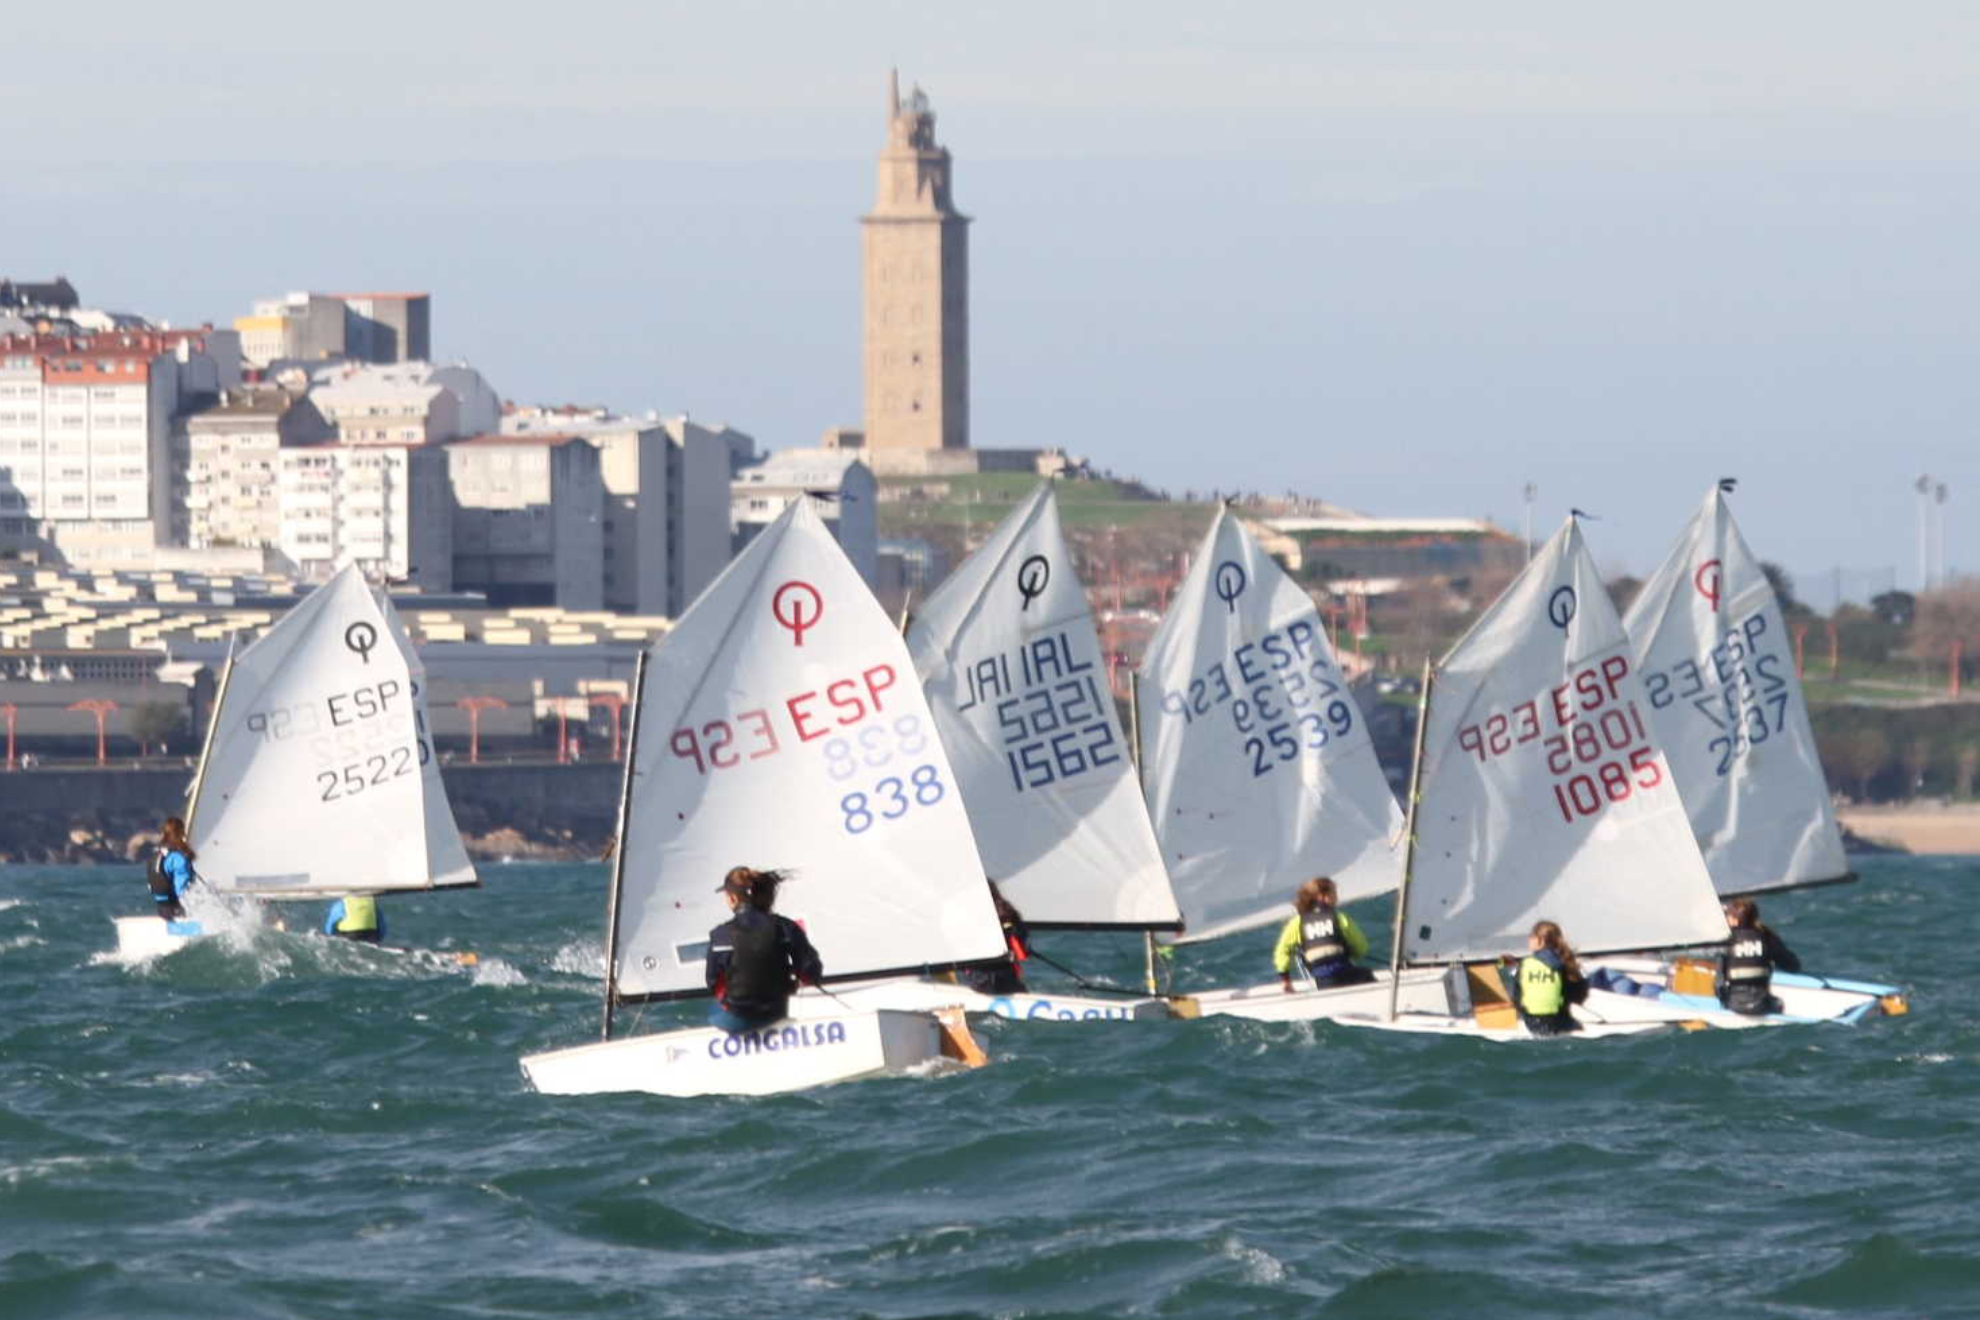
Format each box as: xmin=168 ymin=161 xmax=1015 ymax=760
xmin=859 ymin=73 xmax=970 ymax=473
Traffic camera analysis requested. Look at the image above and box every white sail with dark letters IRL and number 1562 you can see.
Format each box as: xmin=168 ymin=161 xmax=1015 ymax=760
xmin=907 ymin=483 xmax=1180 ymax=926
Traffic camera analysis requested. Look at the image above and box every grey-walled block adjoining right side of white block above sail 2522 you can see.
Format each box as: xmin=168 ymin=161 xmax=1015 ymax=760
xmin=447 ymin=433 xmax=606 ymax=610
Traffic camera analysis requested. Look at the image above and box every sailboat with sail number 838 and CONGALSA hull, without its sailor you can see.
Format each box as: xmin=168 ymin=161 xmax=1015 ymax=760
xmin=521 ymin=499 xmax=1004 ymax=1096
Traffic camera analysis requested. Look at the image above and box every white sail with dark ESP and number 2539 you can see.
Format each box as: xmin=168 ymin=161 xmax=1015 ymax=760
xmin=1140 ymin=500 xmax=1402 ymax=940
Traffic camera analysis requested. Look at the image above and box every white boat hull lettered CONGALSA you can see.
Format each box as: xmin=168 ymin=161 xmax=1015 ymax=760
xmin=523 ymin=1009 xmax=970 ymax=1096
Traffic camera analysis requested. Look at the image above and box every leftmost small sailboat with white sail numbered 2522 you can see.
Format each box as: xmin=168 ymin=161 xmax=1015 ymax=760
xmin=115 ymin=566 xmax=477 ymax=958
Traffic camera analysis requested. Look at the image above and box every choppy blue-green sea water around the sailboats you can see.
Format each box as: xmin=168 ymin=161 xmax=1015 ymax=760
xmin=0 ymin=857 xmax=1980 ymax=1320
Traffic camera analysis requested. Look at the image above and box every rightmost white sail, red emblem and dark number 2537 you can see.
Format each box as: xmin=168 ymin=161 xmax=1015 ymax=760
xmin=1624 ymin=487 xmax=1849 ymax=895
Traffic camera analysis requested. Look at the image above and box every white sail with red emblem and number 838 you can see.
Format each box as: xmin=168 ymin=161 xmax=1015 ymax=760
xmin=614 ymin=499 xmax=1004 ymax=999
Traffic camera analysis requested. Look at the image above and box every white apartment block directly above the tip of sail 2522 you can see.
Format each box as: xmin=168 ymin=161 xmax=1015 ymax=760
xmin=279 ymin=441 xmax=453 ymax=592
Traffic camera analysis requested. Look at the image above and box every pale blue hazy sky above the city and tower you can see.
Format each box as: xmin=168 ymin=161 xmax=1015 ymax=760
xmin=0 ymin=0 xmax=1980 ymax=608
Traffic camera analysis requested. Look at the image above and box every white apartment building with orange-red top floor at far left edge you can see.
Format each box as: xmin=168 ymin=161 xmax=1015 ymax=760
xmin=0 ymin=329 xmax=240 ymax=566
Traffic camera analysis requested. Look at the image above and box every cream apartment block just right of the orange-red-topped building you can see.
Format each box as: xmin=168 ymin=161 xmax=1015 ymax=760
xmin=180 ymin=388 xmax=335 ymax=550
